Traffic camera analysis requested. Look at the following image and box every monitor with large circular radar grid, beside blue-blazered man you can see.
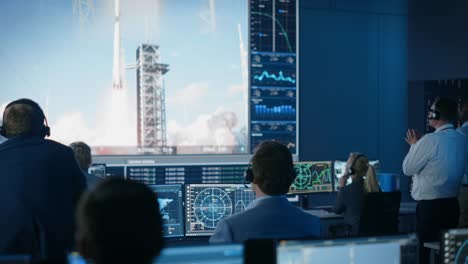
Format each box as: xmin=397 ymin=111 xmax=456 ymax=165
xmin=185 ymin=184 xmax=255 ymax=236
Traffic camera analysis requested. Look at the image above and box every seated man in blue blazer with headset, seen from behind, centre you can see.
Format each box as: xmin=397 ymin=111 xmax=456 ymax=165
xmin=210 ymin=141 xmax=319 ymax=243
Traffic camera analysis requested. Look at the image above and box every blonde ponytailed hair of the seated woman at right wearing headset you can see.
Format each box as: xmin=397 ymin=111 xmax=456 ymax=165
xmin=351 ymin=153 xmax=380 ymax=192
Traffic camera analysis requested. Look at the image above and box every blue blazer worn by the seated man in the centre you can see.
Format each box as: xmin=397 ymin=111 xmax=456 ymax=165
xmin=210 ymin=196 xmax=320 ymax=243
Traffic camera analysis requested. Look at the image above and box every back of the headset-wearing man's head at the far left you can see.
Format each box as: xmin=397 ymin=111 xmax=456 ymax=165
xmin=1 ymin=98 xmax=49 ymax=138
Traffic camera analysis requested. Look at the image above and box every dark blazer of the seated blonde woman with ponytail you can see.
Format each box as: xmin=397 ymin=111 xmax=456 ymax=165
xmin=334 ymin=179 xmax=366 ymax=234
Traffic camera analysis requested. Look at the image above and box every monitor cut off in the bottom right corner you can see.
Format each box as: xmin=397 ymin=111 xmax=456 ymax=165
xmin=441 ymin=229 xmax=468 ymax=263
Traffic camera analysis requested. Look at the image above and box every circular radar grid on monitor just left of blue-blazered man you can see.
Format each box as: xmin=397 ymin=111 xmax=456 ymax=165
xmin=193 ymin=188 xmax=232 ymax=228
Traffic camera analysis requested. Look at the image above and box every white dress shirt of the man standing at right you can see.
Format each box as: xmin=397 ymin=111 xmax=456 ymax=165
xmin=403 ymin=124 xmax=466 ymax=201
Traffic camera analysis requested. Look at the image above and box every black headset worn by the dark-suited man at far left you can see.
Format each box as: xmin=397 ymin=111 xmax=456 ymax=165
xmin=0 ymin=98 xmax=50 ymax=138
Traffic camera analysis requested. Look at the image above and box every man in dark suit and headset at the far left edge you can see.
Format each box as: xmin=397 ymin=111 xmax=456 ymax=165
xmin=0 ymin=99 xmax=86 ymax=261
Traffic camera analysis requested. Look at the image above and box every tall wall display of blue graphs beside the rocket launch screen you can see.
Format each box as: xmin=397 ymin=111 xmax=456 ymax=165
xmin=249 ymin=0 xmax=298 ymax=154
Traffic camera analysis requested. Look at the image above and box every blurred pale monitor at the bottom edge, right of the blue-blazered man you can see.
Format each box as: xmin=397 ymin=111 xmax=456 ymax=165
xmin=277 ymin=235 xmax=418 ymax=264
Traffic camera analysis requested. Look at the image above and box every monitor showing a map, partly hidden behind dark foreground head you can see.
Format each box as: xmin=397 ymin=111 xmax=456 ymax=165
xmin=149 ymin=185 xmax=184 ymax=237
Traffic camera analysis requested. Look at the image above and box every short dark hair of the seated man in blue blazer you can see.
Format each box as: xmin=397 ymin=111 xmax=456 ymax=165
xmin=252 ymin=141 xmax=295 ymax=195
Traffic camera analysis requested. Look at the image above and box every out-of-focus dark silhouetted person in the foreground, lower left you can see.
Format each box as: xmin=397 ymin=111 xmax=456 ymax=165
xmin=76 ymin=179 xmax=163 ymax=264
